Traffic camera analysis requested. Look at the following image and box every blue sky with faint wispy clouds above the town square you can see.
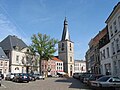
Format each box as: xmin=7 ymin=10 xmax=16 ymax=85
xmin=0 ymin=0 xmax=119 ymax=60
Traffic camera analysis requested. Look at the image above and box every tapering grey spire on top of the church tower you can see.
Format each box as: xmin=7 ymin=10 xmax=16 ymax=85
xmin=62 ymin=17 xmax=70 ymax=41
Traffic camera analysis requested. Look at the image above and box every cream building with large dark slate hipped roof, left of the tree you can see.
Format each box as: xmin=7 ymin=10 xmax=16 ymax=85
xmin=0 ymin=35 xmax=38 ymax=73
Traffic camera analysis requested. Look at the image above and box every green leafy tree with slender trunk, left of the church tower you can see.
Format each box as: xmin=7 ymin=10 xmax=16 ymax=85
xmin=31 ymin=33 xmax=58 ymax=73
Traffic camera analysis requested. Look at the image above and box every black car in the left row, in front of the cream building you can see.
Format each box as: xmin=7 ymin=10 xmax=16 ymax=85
xmin=13 ymin=73 xmax=30 ymax=82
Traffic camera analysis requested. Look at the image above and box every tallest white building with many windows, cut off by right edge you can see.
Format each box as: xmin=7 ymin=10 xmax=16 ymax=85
xmin=106 ymin=2 xmax=120 ymax=76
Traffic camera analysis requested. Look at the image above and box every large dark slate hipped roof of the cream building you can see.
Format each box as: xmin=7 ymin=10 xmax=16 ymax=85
xmin=0 ymin=35 xmax=27 ymax=50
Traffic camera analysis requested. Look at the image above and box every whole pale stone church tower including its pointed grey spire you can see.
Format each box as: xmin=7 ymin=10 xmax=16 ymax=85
xmin=58 ymin=18 xmax=74 ymax=76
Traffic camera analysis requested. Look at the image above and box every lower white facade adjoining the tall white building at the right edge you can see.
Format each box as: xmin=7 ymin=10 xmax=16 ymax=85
xmin=100 ymin=43 xmax=114 ymax=75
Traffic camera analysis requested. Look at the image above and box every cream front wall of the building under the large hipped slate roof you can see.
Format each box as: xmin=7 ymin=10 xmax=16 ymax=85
xmin=11 ymin=48 xmax=32 ymax=73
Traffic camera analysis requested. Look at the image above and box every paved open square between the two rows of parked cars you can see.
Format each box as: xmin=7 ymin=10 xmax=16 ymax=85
xmin=0 ymin=78 xmax=90 ymax=90
